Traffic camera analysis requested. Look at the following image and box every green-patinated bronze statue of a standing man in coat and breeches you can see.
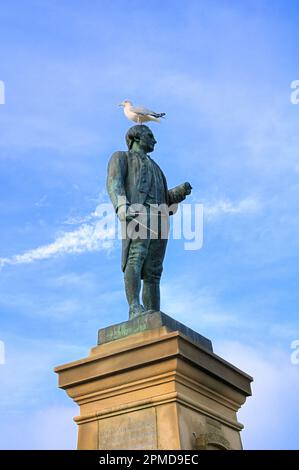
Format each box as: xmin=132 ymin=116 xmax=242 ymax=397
xmin=107 ymin=125 xmax=192 ymax=319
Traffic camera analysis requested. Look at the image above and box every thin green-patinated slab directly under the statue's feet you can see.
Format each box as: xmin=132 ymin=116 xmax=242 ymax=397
xmin=98 ymin=312 xmax=213 ymax=351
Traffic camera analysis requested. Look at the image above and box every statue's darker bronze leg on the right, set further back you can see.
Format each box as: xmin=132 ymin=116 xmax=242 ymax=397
xmin=142 ymin=239 xmax=167 ymax=311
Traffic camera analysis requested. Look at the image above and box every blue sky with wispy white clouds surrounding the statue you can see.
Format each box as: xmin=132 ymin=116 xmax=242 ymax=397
xmin=0 ymin=0 xmax=299 ymax=449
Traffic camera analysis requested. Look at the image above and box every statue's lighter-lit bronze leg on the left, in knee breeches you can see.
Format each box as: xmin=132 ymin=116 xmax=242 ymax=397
xmin=125 ymin=239 xmax=149 ymax=318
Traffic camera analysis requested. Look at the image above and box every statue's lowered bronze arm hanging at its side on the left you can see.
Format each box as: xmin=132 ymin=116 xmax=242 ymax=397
xmin=107 ymin=152 xmax=128 ymax=213
